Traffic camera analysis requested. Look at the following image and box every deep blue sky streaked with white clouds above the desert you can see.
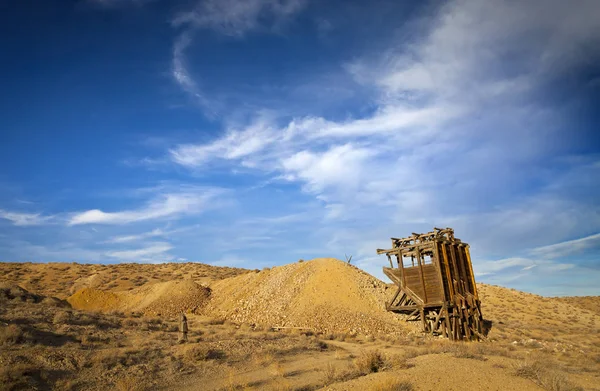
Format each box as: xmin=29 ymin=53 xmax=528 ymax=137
xmin=0 ymin=0 xmax=600 ymax=296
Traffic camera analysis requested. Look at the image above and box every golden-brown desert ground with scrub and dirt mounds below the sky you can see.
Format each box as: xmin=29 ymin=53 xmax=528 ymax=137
xmin=0 ymin=258 xmax=600 ymax=391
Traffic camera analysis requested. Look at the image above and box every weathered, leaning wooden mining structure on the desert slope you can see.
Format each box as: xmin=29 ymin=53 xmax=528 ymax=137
xmin=377 ymin=228 xmax=484 ymax=340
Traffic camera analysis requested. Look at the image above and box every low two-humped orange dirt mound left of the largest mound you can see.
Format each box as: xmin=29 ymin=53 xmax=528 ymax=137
xmin=67 ymin=280 xmax=210 ymax=317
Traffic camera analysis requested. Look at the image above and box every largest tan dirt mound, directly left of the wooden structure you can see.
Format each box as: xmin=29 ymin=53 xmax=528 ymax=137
xmin=205 ymin=258 xmax=412 ymax=334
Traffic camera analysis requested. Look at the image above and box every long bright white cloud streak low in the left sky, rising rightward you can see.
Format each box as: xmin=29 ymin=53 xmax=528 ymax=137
xmin=69 ymin=188 xmax=222 ymax=225
